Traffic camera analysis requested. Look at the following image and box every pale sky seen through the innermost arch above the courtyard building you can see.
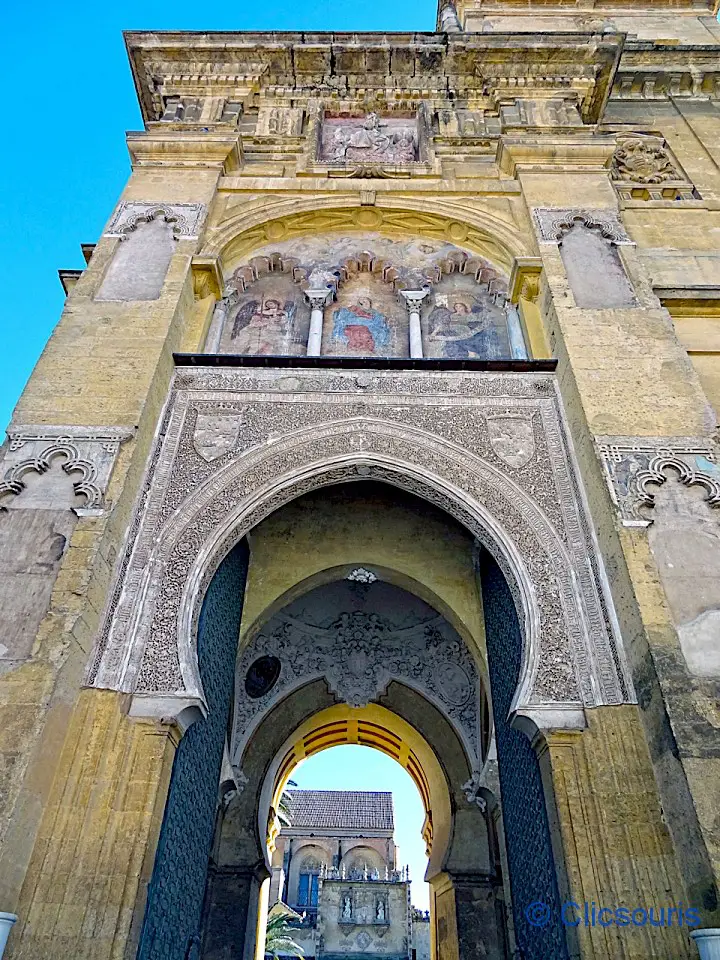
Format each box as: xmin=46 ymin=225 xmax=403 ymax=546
xmin=292 ymin=746 xmax=430 ymax=910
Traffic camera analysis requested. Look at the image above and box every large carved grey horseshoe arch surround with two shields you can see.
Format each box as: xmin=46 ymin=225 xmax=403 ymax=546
xmin=87 ymin=368 xmax=632 ymax=728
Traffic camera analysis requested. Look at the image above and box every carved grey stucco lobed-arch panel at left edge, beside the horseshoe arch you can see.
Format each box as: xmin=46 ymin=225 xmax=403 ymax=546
xmin=0 ymin=425 xmax=132 ymax=516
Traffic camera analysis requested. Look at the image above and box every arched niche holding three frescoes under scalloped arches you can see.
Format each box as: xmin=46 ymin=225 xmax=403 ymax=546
xmin=206 ymin=231 xmax=527 ymax=360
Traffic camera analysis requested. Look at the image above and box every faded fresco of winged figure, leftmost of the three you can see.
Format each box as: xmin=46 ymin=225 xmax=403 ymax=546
xmin=219 ymin=276 xmax=310 ymax=356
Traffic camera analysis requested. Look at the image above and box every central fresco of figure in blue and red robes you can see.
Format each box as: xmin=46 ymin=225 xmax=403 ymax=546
xmin=323 ymin=274 xmax=402 ymax=357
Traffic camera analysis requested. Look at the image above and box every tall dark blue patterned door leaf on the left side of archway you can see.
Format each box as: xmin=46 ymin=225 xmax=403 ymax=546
xmin=137 ymin=541 xmax=248 ymax=960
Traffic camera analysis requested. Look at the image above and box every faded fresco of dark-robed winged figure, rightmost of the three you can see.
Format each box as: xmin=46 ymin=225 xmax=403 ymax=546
xmin=423 ymin=275 xmax=512 ymax=360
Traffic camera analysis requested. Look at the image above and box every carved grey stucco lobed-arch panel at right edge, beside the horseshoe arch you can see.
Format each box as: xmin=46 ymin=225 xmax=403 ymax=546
xmin=597 ymin=437 xmax=720 ymax=527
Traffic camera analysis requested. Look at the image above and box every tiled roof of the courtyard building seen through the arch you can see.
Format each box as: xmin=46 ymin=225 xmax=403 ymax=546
xmin=288 ymin=790 xmax=394 ymax=830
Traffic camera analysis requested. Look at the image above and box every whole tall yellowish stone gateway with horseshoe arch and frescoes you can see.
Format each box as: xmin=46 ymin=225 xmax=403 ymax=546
xmin=0 ymin=0 xmax=720 ymax=960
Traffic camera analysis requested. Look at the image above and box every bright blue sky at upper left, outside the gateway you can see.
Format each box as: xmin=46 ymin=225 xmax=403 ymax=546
xmin=0 ymin=0 xmax=436 ymax=430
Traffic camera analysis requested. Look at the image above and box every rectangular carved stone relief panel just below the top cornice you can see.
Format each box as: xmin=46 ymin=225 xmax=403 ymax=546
xmin=320 ymin=113 xmax=417 ymax=163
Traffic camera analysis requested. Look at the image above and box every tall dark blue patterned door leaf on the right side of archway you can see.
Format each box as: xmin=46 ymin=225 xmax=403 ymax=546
xmin=481 ymin=551 xmax=568 ymax=960
